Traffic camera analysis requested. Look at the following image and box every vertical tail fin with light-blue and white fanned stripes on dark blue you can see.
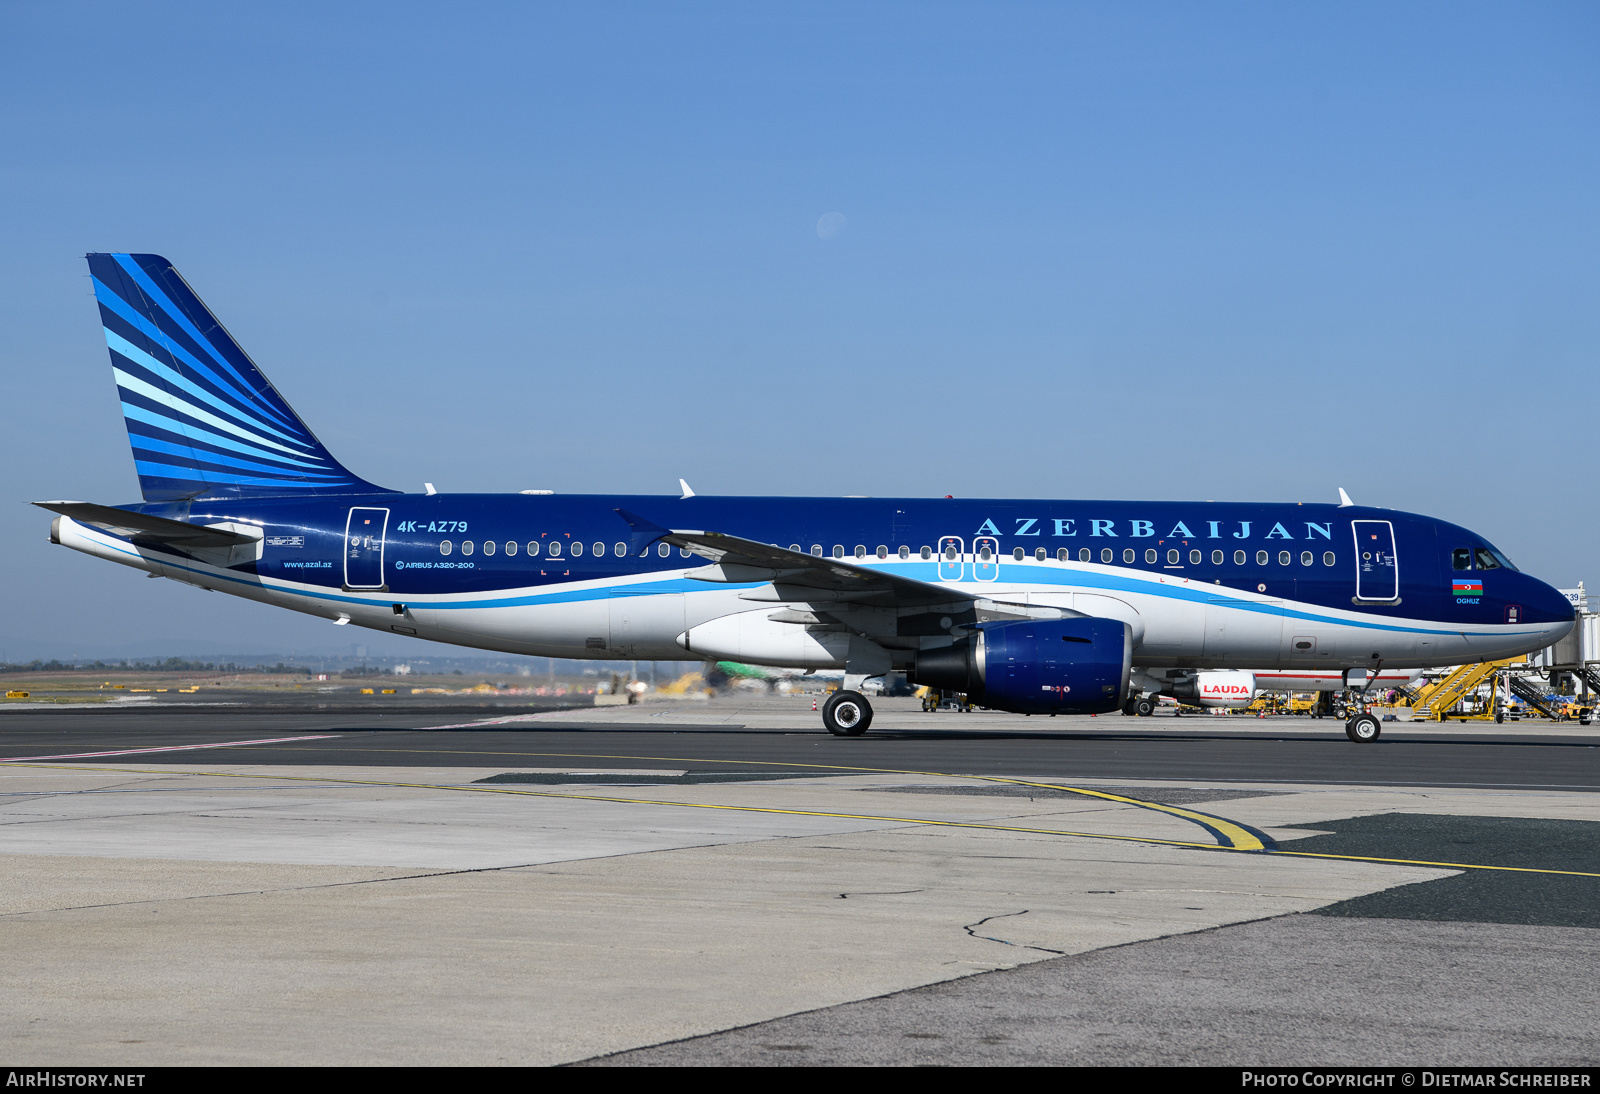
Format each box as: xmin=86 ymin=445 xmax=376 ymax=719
xmin=86 ymin=254 xmax=394 ymax=502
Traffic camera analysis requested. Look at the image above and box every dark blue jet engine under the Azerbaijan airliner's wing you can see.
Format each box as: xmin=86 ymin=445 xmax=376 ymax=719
xmin=907 ymin=617 xmax=1133 ymax=713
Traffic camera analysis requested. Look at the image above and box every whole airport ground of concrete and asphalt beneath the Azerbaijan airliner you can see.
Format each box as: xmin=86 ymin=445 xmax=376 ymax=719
xmin=0 ymin=697 xmax=1600 ymax=1065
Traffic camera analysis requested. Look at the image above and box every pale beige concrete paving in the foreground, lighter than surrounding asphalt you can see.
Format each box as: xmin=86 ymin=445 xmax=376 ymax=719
xmin=0 ymin=765 xmax=1536 ymax=1065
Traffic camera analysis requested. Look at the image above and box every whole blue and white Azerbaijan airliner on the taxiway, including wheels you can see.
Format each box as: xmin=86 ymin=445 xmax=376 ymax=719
xmin=37 ymin=254 xmax=1574 ymax=742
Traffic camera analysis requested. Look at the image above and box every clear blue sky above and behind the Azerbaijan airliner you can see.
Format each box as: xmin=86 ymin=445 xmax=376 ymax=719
xmin=0 ymin=3 xmax=1600 ymax=657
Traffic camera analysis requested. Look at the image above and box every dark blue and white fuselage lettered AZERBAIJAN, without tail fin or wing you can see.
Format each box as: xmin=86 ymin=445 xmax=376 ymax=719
xmin=70 ymin=494 xmax=1574 ymax=667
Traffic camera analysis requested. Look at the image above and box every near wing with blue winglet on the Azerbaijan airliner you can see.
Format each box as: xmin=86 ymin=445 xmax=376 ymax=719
xmin=616 ymin=509 xmax=1062 ymax=622
